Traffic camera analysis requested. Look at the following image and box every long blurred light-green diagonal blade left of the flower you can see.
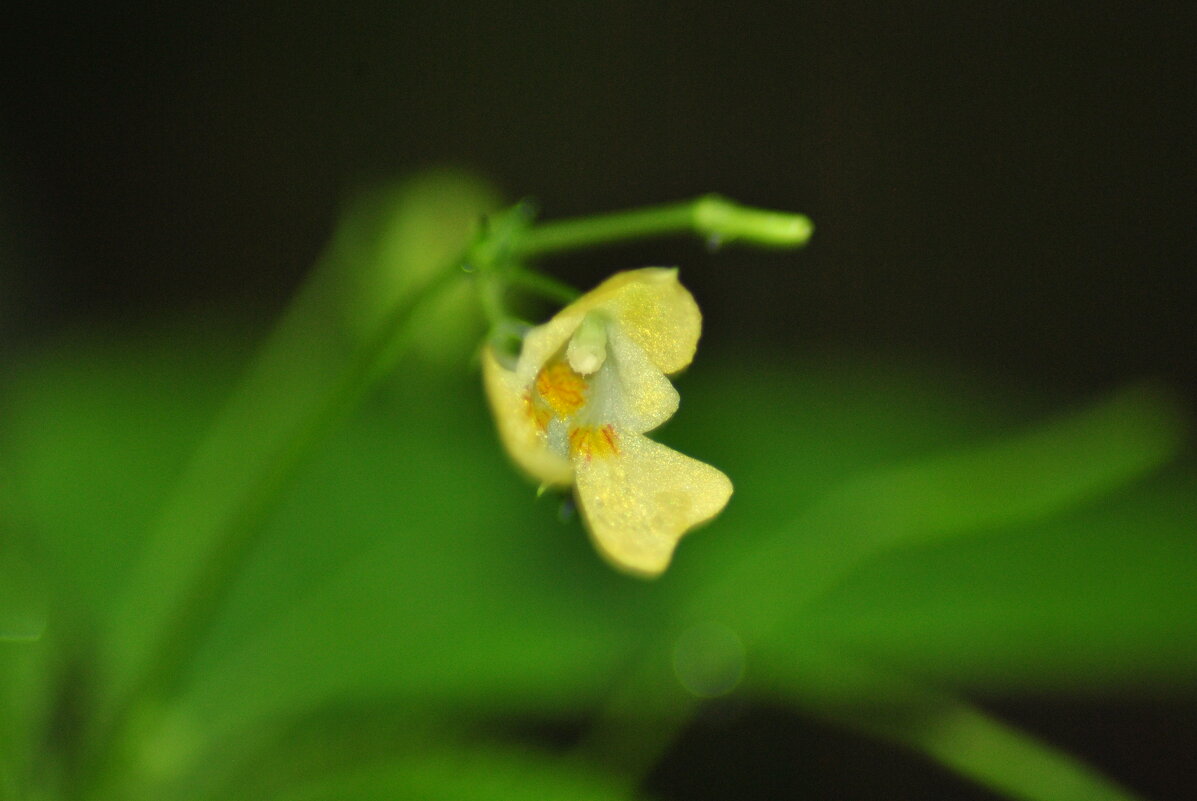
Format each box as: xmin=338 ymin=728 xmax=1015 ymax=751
xmin=99 ymin=167 xmax=494 ymax=726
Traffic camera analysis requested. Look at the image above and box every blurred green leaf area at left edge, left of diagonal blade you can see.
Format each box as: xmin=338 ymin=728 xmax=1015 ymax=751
xmin=0 ymin=329 xmax=239 ymax=629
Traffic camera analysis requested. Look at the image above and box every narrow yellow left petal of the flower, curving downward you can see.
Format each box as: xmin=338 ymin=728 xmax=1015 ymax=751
xmin=482 ymin=346 xmax=573 ymax=485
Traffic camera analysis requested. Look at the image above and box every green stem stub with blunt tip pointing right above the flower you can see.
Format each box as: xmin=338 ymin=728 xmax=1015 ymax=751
xmin=514 ymin=195 xmax=814 ymax=259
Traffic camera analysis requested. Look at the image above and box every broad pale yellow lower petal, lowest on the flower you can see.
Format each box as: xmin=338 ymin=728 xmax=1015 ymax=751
xmin=575 ymin=432 xmax=731 ymax=577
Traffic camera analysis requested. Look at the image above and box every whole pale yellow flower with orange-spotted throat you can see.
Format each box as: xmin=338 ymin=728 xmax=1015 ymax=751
xmin=482 ymin=267 xmax=731 ymax=576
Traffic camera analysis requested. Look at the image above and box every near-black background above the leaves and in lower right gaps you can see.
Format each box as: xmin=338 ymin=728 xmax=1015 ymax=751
xmin=0 ymin=1 xmax=1197 ymax=797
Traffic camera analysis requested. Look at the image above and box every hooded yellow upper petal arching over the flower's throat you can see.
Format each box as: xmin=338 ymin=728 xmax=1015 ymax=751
xmin=516 ymin=267 xmax=703 ymax=382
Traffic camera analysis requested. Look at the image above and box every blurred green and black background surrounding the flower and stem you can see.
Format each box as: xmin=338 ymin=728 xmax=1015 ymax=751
xmin=0 ymin=4 xmax=1197 ymax=799
